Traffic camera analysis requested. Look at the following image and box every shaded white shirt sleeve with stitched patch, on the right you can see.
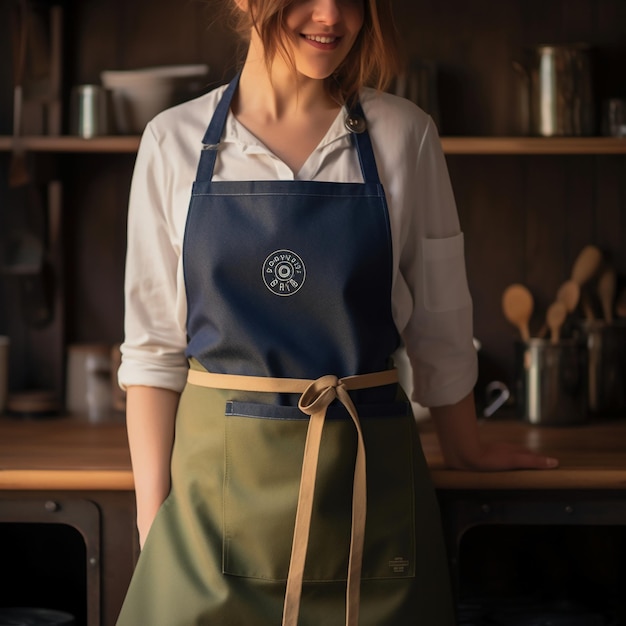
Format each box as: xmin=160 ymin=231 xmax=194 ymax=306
xmin=391 ymin=114 xmax=478 ymax=407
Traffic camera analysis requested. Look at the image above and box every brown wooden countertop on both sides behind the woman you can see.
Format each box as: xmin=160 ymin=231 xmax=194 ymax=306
xmin=0 ymin=416 xmax=626 ymax=491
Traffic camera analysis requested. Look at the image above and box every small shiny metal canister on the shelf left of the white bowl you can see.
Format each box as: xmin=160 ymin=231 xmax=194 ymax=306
xmin=70 ymin=85 xmax=111 ymax=139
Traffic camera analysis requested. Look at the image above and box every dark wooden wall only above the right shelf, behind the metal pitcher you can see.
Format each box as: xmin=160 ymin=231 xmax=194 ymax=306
xmin=394 ymin=0 xmax=626 ymax=135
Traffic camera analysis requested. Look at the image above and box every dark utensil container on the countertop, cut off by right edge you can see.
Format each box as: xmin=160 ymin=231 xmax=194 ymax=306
xmin=584 ymin=320 xmax=626 ymax=416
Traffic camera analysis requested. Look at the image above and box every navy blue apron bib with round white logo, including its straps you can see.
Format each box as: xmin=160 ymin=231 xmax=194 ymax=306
xmin=183 ymin=72 xmax=399 ymax=386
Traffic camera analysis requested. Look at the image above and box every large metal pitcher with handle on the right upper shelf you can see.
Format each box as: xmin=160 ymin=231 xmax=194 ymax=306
xmin=514 ymin=43 xmax=595 ymax=137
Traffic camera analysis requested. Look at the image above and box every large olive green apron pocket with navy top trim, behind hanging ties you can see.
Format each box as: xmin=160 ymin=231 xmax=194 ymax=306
xmin=222 ymin=402 xmax=415 ymax=582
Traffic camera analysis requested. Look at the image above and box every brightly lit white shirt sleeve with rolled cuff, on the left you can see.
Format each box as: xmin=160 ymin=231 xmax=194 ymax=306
xmin=118 ymin=126 xmax=187 ymax=391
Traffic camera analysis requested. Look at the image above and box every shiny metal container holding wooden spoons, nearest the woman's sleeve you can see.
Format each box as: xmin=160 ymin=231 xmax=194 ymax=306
xmin=515 ymin=339 xmax=588 ymax=426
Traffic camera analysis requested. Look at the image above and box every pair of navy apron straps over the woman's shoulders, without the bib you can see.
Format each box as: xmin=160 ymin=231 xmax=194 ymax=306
xmin=196 ymin=72 xmax=380 ymax=184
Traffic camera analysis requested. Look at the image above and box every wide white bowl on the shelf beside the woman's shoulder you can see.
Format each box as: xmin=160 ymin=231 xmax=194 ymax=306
xmin=100 ymin=65 xmax=209 ymax=135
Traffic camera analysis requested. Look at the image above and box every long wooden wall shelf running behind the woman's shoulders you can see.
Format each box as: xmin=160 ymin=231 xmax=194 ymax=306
xmin=0 ymin=136 xmax=626 ymax=155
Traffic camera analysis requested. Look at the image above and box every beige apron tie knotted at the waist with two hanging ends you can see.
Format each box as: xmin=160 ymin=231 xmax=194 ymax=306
xmin=187 ymin=369 xmax=398 ymax=626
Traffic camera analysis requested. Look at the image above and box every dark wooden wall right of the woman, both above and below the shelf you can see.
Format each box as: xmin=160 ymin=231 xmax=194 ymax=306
xmin=394 ymin=0 xmax=626 ymax=385
